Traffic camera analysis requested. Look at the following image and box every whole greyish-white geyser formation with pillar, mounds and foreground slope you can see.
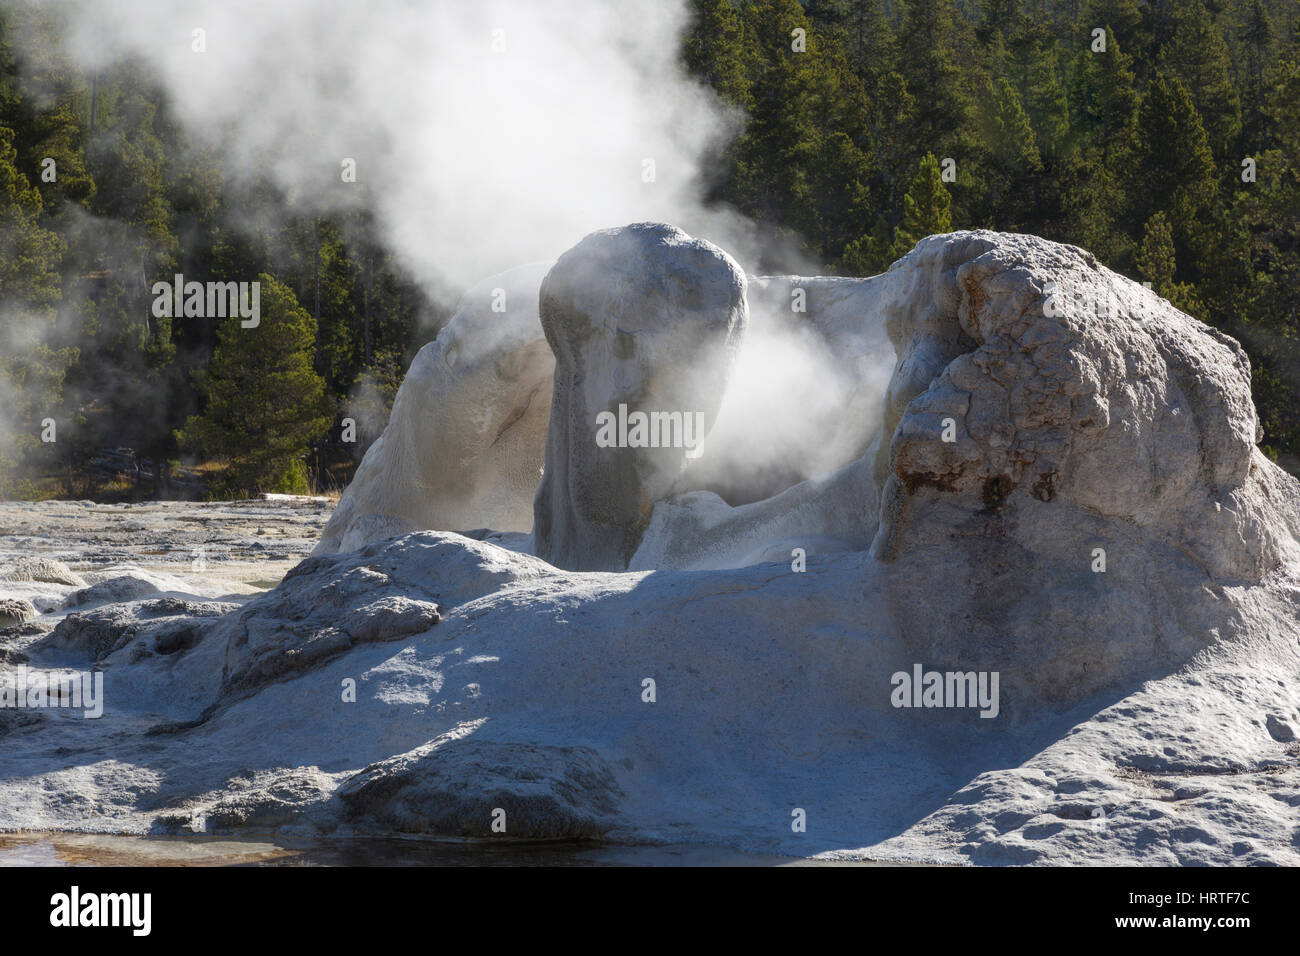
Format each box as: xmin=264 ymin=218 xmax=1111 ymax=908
xmin=0 ymin=224 xmax=1300 ymax=865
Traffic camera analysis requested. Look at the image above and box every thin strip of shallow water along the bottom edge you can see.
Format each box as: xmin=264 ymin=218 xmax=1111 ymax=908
xmin=0 ymin=832 xmax=883 ymax=866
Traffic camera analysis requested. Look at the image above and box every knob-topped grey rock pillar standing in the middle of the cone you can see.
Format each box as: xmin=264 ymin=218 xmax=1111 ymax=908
xmin=533 ymin=222 xmax=746 ymax=570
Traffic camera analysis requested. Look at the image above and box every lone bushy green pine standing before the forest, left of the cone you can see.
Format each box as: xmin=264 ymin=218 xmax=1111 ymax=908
xmin=177 ymin=273 xmax=332 ymax=493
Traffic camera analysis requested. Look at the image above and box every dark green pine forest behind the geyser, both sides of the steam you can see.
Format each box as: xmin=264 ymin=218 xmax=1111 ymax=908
xmin=0 ymin=0 xmax=1300 ymax=494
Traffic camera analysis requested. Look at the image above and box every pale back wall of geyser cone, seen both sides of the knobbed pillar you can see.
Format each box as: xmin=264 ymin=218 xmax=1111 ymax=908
xmin=316 ymin=257 xmax=893 ymax=554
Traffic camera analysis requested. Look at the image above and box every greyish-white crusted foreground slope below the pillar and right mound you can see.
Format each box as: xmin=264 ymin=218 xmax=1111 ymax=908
xmin=0 ymin=532 xmax=1300 ymax=865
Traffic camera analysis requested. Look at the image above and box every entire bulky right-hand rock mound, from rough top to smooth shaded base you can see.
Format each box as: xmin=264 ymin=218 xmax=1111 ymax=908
xmin=874 ymin=233 xmax=1300 ymax=698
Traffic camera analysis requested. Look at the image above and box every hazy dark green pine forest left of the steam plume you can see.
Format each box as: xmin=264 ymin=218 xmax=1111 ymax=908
xmin=0 ymin=1 xmax=421 ymax=496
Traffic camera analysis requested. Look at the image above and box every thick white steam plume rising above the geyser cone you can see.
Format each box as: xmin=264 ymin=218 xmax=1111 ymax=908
xmin=43 ymin=0 xmax=749 ymax=295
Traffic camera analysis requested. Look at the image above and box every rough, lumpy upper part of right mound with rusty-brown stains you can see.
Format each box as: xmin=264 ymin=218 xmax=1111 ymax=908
xmin=876 ymin=233 xmax=1296 ymax=580
